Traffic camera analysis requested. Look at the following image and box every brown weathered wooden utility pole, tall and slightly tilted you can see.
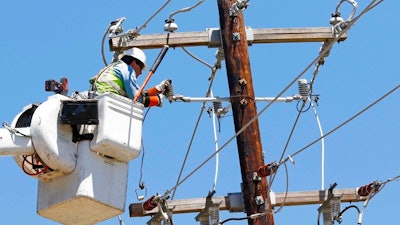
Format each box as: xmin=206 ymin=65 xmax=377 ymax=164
xmin=218 ymin=0 xmax=274 ymax=225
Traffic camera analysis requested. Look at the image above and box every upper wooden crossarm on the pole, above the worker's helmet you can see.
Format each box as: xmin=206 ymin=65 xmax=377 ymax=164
xmin=109 ymin=27 xmax=347 ymax=51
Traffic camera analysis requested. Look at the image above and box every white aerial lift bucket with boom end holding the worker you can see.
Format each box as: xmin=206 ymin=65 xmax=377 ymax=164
xmin=0 ymin=80 xmax=143 ymax=225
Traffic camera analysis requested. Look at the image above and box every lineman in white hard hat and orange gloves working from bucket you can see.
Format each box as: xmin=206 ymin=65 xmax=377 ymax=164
xmin=90 ymin=48 xmax=171 ymax=107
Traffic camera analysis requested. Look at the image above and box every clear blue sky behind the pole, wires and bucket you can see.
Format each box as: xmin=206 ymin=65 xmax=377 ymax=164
xmin=0 ymin=0 xmax=400 ymax=225
